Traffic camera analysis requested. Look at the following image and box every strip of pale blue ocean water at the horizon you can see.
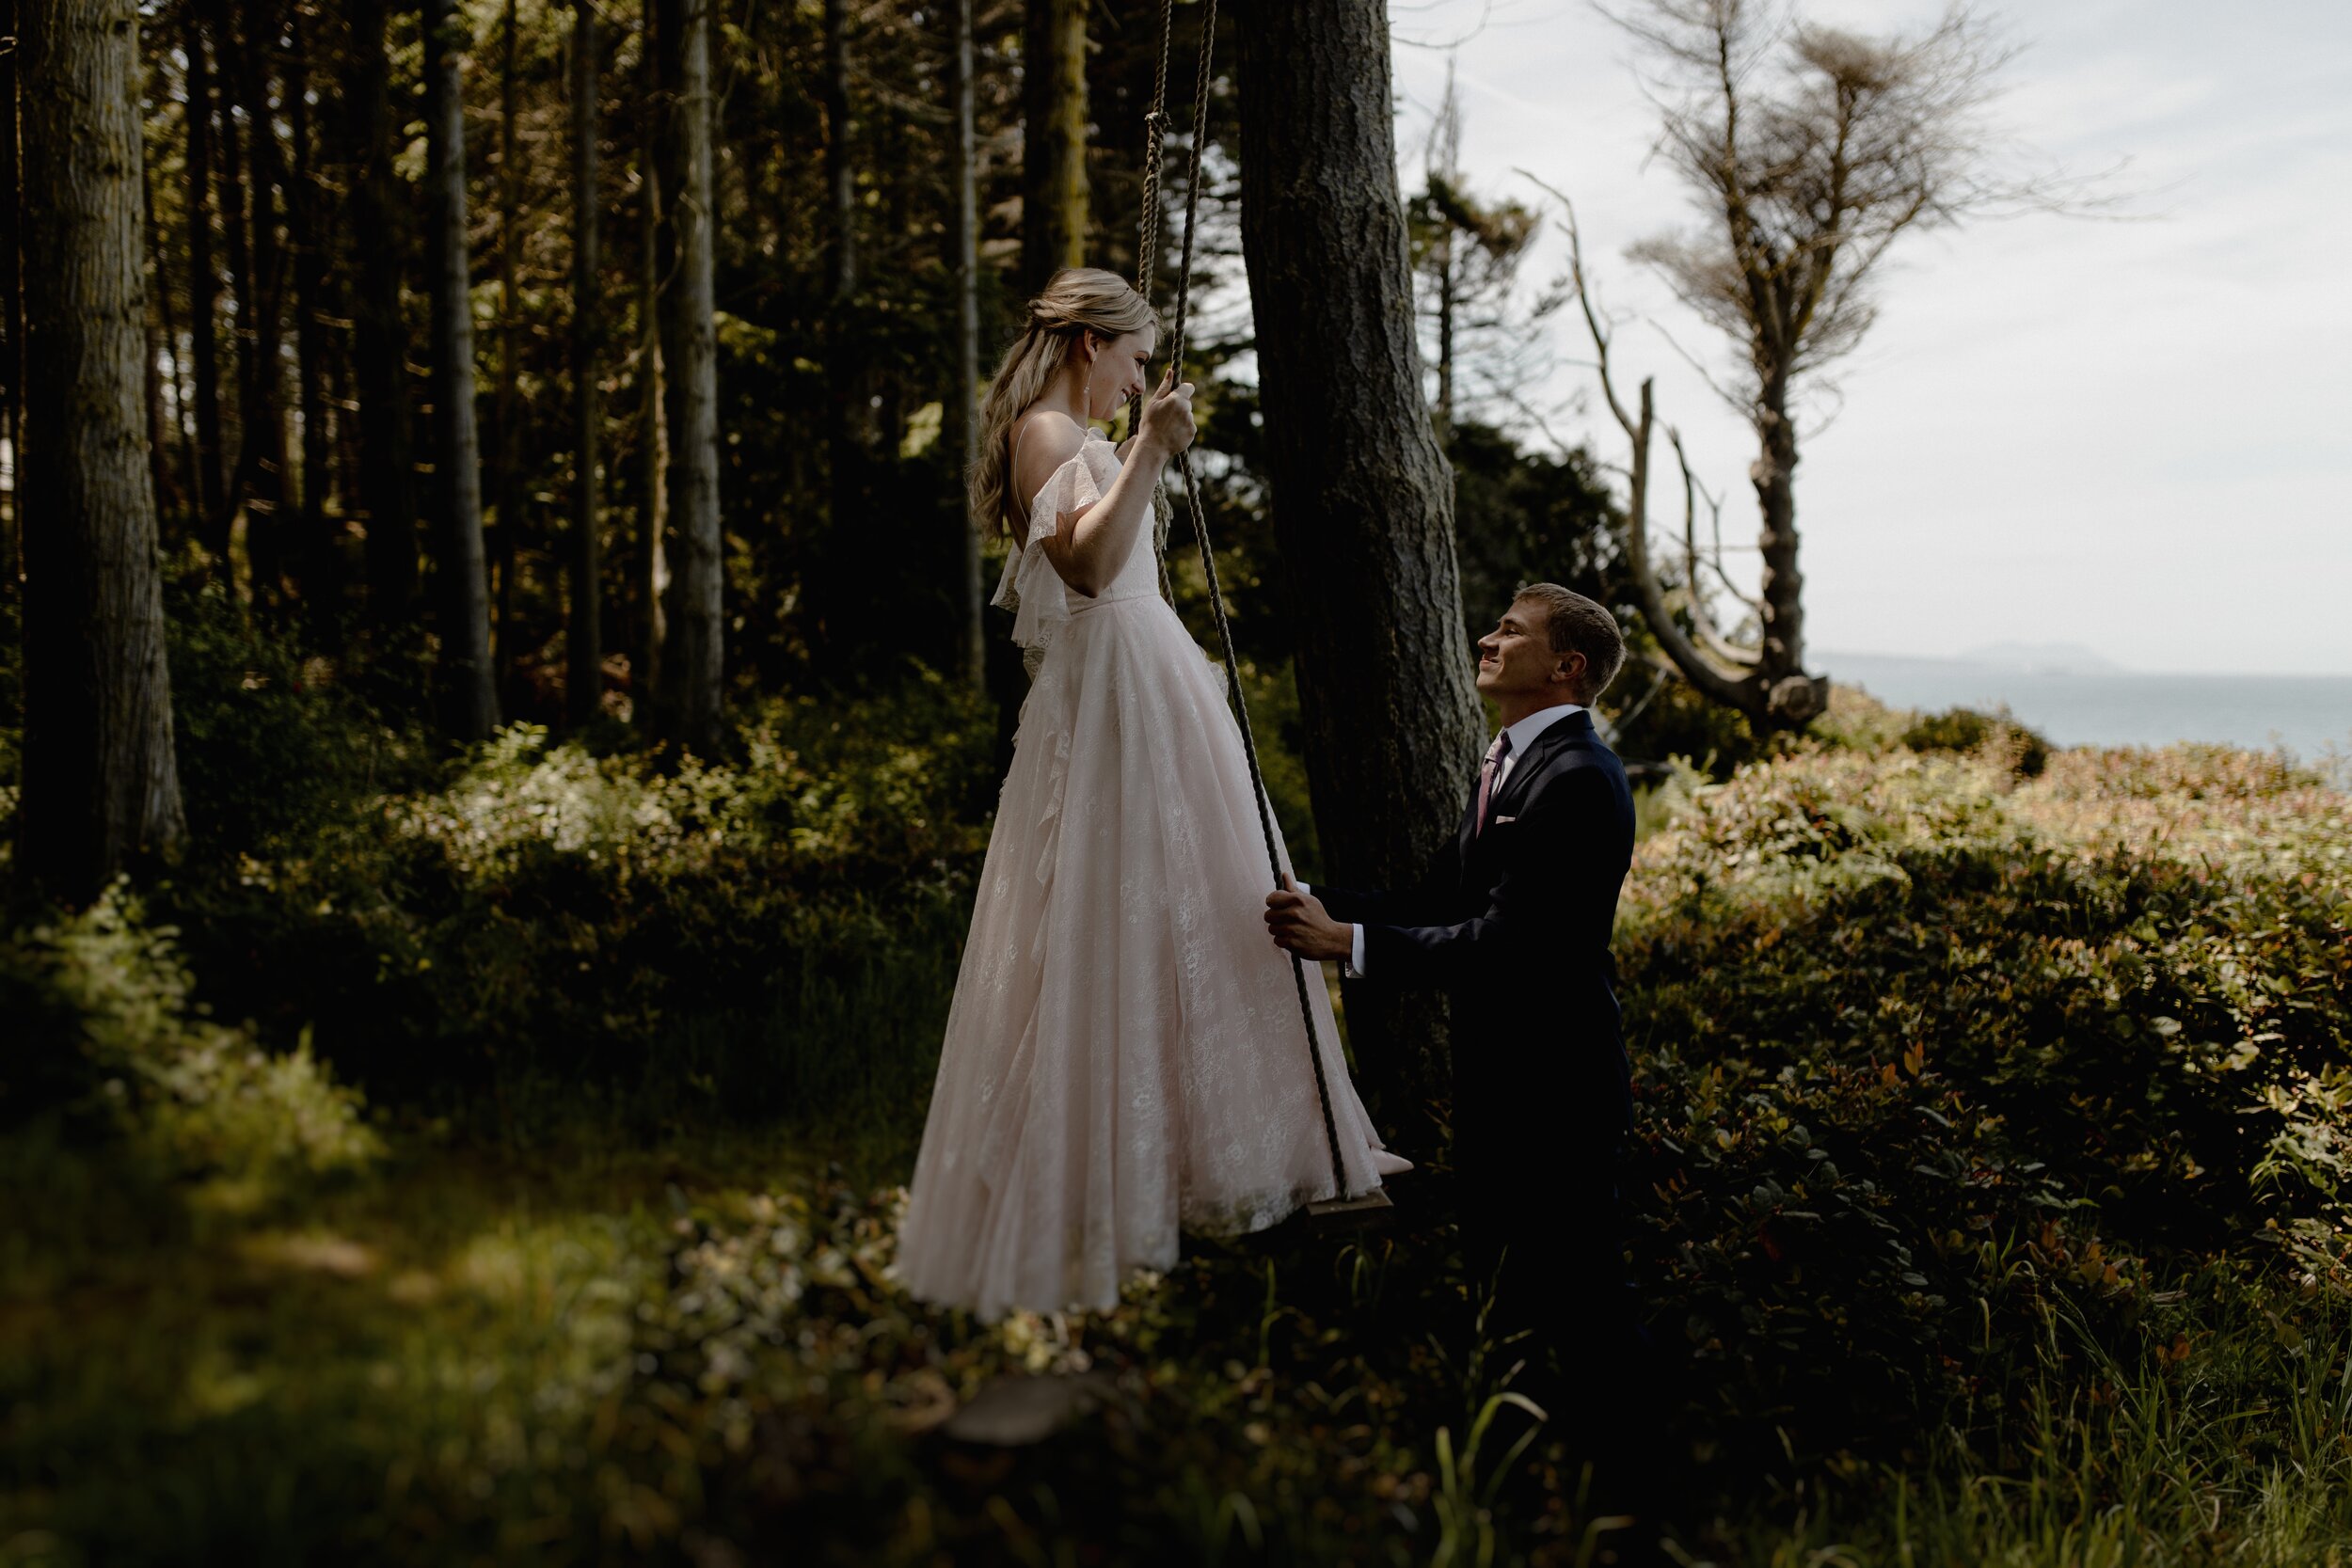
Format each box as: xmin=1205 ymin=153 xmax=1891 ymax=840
xmin=1816 ymin=654 xmax=2352 ymax=762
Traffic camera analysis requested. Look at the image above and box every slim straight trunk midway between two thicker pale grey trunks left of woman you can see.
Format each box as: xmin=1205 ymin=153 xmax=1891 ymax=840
xmin=564 ymin=0 xmax=605 ymax=726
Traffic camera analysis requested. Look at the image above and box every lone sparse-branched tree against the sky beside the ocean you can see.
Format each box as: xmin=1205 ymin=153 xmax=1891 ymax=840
xmin=1588 ymin=0 xmax=2068 ymax=729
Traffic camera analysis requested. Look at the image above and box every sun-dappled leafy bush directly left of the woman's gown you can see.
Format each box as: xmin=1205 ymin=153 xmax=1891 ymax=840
xmin=163 ymin=682 xmax=993 ymax=1126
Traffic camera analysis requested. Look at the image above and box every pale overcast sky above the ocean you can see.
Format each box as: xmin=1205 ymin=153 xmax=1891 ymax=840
xmin=1391 ymin=0 xmax=2352 ymax=674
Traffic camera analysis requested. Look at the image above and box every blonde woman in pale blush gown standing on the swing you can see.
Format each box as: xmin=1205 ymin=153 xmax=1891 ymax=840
xmin=898 ymin=268 xmax=1409 ymax=1319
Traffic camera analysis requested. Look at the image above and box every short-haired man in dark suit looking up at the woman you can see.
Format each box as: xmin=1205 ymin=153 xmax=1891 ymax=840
xmin=1265 ymin=583 xmax=1635 ymax=1436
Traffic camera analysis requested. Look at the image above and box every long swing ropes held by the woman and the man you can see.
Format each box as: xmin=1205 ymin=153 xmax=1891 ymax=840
xmin=1136 ymin=0 xmax=1355 ymax=1204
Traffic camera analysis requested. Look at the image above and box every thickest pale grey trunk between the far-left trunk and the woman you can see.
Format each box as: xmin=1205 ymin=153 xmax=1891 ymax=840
xmin=657 ymin=0 xmax=727 ymax=752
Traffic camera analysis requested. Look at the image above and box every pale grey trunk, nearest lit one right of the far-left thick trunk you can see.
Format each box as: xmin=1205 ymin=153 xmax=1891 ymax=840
xmin=423 ymin=0 xmax=499 ymax=740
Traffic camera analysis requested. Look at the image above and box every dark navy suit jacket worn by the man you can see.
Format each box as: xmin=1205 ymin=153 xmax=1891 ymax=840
xmin=1315 ymin=712 xmax=1632 ymax=1176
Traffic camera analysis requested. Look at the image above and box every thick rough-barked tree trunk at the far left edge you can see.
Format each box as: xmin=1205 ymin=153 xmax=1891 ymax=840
xmin=17 ymin=0 xmax=183 ymax=898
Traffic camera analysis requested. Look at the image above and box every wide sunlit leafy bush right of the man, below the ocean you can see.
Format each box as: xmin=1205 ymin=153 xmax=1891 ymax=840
xmin=1618 ymin=750 xmax=2352 ymax=1495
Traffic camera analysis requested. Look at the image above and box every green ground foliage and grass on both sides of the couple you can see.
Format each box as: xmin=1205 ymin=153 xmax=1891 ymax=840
xmin=0 ymin=700 xmax=2352 ymax=1563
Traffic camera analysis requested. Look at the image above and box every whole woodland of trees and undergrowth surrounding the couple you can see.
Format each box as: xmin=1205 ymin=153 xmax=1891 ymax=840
xmin=13 ymin=0 xmax=2352 ymax=1568
